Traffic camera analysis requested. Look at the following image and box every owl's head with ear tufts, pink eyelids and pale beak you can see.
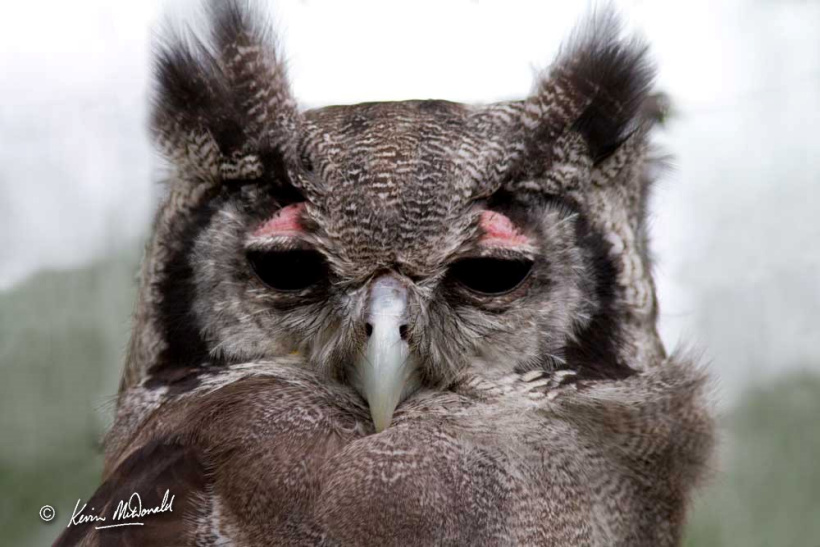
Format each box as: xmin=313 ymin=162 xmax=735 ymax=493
xmin=130 ymin=2 xmax=663 ymax=430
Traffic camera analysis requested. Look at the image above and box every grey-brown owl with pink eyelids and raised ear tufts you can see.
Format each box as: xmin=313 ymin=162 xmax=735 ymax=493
xmin=57 ymin=1 xmax=713 ymax=547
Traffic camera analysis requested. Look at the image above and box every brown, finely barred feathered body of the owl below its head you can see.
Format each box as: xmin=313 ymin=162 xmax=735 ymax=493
xmin=55 ymin=358 xmax=711 ymax=546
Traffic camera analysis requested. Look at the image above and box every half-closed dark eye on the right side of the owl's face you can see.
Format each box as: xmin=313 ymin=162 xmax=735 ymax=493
xmin=450 ymin=258 xmax=532 ymax=295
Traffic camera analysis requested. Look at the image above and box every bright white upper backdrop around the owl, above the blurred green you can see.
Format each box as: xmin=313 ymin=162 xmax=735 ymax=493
xmin=0 ymin=0 xmax=820 ymax=402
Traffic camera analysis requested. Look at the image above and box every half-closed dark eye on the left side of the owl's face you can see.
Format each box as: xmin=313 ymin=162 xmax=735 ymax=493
xmin=247 ymin=249 xmax=327 ymax=292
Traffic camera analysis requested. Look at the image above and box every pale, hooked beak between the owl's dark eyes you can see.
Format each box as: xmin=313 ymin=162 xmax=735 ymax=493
xmin=356 ymin=275 xmax=415 ymax=432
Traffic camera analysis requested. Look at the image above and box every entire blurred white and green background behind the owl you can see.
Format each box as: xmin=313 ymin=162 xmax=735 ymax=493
xmin=0 ymin=0 xmax=820 ymax=547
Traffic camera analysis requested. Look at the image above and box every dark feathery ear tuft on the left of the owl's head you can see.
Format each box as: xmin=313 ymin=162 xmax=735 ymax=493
xmin=152 ymin=0 xmax=299 ymax=183
